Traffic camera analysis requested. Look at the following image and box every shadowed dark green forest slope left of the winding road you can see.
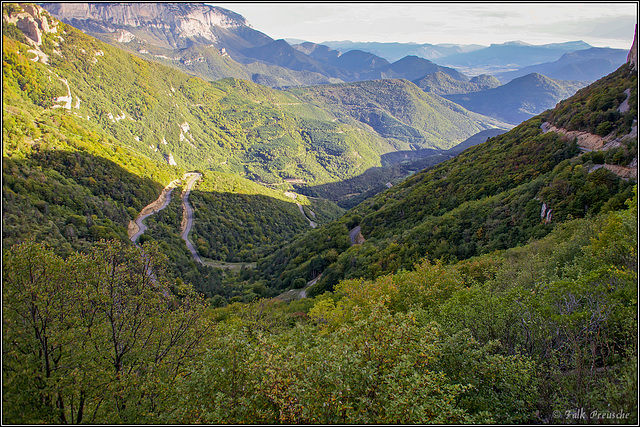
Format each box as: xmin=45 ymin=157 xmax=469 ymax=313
xmin=2 ymin=150 xmax=161 ymax=254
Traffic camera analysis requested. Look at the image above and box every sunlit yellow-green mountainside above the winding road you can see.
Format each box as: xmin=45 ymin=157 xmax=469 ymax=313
xmin=3 ymin=8 xmax=504 ymax=189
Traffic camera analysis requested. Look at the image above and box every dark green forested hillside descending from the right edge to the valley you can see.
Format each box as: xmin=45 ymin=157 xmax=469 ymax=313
xmin=252 ymin=59 xmax=637 ymax=295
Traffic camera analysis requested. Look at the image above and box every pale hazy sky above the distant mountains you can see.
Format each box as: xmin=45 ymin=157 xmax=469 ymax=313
xmin=208 ymin=2 xmax=638 ymax=49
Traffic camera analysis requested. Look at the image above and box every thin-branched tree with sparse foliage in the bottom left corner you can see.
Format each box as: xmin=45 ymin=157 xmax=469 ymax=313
xmin=3 ymin=241 xmax=206 ymax=423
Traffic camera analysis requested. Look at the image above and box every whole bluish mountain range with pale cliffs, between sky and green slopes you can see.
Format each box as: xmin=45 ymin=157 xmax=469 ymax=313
xmin=43 ymin=3 xmax=626 ymax=129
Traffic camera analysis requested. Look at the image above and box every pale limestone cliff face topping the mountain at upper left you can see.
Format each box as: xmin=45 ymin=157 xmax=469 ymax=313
xmin=42 ymin=3 xmax=251 ymax=47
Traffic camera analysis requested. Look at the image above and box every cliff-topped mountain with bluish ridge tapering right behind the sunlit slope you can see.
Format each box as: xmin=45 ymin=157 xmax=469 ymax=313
xmin=43 ymin=3 xmax=476 ymax=87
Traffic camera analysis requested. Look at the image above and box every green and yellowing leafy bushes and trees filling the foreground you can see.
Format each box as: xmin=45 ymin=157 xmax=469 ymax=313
xmin=3 ymin=189 xmax=638 ymax=424
